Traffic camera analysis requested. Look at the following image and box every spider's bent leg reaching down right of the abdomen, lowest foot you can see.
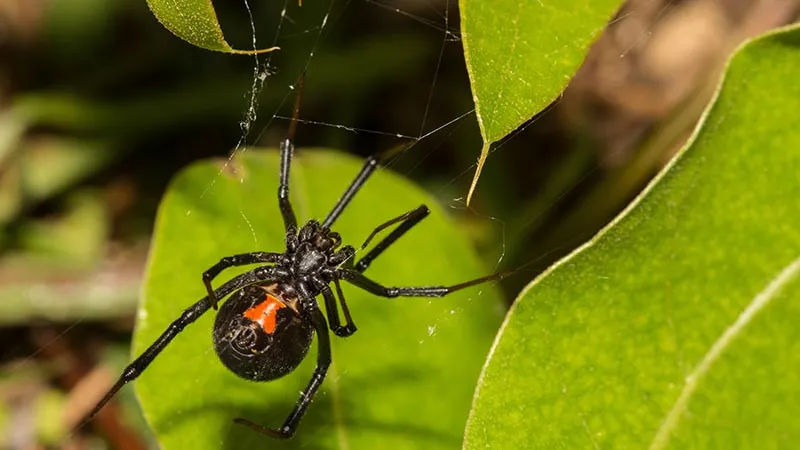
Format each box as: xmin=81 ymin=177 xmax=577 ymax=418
xmin=233 ymin=285 xmax=331 ymax=439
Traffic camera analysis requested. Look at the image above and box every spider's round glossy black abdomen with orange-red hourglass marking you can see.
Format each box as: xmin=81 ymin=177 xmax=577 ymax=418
xmin=213 ymin=286 xmax=314 ymax=381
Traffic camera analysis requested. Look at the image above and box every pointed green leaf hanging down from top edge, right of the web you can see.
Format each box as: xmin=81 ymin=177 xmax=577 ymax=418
xmin=459 ymin=0 xmax=621 ymax=203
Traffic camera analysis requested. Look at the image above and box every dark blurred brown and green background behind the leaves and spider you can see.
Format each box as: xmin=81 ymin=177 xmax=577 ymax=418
xmin=0 ymin=0 xmax=800 ymax=449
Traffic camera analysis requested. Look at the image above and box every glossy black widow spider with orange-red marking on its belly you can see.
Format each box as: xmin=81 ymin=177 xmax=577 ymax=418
xmin=82 ymin=77 xmax=507 ymax=438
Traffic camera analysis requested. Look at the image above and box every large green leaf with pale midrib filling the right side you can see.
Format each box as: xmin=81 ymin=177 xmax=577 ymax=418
xmin=465 ymin=27 xmax=800 ymax=449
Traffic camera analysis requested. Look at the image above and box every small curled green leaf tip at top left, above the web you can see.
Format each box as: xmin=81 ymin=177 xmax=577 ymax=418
xmin=147 ymin=0 xmax=278 ymax=55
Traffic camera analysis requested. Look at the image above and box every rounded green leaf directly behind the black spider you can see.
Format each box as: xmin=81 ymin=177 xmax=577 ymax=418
xmin=134 ymin=149 xmax=503 ymax=450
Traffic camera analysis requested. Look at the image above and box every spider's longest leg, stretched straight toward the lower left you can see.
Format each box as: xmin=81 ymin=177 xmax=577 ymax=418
xmin=75 ymin=269 xmax=268 ymax=430
